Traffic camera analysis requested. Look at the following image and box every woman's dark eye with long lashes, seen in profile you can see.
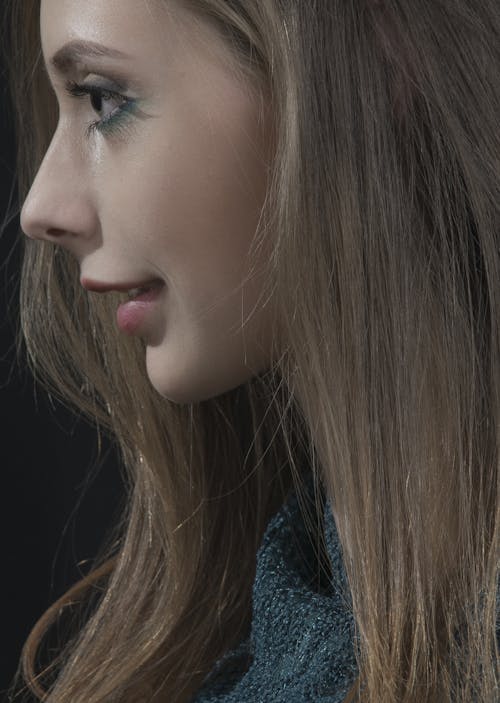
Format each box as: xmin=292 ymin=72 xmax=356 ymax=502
xmin=66 ymin=81 xmax=135 ymax=138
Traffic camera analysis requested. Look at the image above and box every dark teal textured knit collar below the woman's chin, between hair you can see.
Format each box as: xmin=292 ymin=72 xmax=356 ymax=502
xmin=193 ymin=484 xmax=358 ymax=703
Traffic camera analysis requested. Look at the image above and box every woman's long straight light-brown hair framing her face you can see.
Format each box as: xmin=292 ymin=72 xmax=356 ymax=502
xmin=1 ymin=0 xmax=500 ymax=703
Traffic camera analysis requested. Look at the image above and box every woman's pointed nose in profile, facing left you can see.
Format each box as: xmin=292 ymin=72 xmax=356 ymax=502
xmin=21 ymin=131 xmax=98 ymax=257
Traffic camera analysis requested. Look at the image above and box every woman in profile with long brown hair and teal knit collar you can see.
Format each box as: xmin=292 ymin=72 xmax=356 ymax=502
xmin=2 ymin=0 xmax=500 ymax=703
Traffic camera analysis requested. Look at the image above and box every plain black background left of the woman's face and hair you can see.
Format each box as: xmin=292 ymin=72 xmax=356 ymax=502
xmin=0 ymin=56 xmax=123 ymax=699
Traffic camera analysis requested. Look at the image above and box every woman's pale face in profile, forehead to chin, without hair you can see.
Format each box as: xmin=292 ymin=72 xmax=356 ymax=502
xmin=21 ymin=0 xmax=272 ymax=403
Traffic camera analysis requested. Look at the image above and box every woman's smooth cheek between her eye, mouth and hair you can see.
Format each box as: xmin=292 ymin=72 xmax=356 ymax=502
xmin=113 ymin=103 xmax=266 ymax=302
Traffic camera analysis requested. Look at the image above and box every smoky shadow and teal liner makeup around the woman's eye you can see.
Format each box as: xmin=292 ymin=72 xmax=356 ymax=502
xmin=65 ymin=80 xmax=138 ymax=137
